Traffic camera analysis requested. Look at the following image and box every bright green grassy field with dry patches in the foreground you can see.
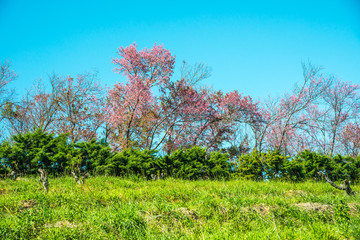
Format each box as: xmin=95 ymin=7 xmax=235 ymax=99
xmin=0 ymin=177 xmax=360 ymax=239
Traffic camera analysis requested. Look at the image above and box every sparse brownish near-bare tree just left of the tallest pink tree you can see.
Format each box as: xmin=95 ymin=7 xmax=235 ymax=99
xmin=50 ymin=73 xmax=105 ymax=142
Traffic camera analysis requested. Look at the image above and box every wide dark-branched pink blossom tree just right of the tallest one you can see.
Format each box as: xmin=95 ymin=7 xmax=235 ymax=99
xmin=155 ymin=74 xmax=260 ymax=153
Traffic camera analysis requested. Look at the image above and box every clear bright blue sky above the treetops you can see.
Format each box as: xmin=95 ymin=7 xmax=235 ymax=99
xmin=0 ymin=0 xmax=360 ymax=99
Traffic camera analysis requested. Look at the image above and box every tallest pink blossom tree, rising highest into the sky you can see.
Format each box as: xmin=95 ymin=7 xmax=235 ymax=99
xmin=106 ymin=43 xmax=175 ymax=149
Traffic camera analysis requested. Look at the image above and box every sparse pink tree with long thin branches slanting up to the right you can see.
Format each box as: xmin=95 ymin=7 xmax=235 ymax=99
xmin=253 ymin=63 xmax=332 ymax=154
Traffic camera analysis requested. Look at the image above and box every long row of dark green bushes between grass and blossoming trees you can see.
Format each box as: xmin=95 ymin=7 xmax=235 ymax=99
xmin=0 ymin=130 xmax=360 ymax=181
